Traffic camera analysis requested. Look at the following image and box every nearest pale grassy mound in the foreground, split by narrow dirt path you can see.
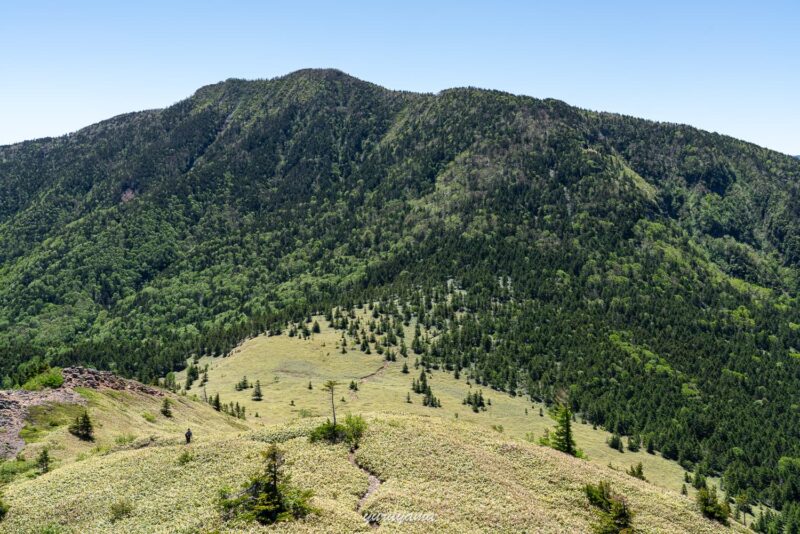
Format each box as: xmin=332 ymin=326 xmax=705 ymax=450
xmin=0 ymin=415 xmax=738 ymax=533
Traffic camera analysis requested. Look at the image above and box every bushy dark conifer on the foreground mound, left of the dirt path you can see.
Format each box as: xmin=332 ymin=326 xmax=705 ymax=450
xmin=220 ymin=444 xmax=314 ymax=525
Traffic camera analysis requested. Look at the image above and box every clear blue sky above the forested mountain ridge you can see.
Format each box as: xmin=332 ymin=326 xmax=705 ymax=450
xmin=0 ymin=0 xmax=800 ymax=154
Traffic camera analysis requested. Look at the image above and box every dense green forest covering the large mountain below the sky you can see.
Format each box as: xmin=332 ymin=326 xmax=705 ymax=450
xmin=0 ymin=70 xmax=800 ymax=529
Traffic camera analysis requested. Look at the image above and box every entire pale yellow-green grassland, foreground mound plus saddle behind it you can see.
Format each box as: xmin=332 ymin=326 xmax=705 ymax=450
xmin=0 ymin=310 xmax=742 ymax=533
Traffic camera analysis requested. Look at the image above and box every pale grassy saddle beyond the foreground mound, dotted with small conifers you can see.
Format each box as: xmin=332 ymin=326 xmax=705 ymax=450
xmin=179 ymin=310 xmax=708 ymax=494
